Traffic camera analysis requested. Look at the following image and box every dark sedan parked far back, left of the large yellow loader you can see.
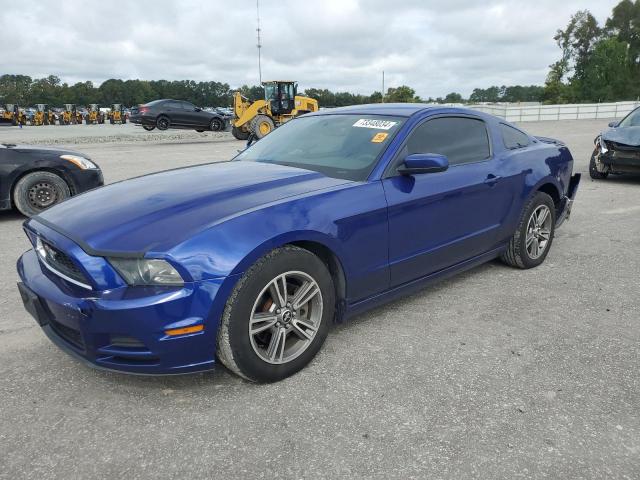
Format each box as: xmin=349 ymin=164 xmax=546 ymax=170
xmin=129 ymin=99 xmax=226 ymax=132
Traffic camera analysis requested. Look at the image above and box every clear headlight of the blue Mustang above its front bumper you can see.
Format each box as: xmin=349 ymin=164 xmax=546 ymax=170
xmin=109 ymin=258 xmax=184 ymax=285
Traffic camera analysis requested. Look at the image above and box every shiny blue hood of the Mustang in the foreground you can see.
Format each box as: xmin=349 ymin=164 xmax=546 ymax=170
xmin=31 ymin=161 xmax=351 ymax=255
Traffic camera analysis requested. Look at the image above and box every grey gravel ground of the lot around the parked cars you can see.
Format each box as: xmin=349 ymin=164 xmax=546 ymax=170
xmin=0 ymin=120 xmax=640 ymax=479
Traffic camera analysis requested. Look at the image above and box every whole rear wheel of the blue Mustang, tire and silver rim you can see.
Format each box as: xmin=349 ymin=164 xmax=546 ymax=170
xmin=501 ymin=192 xmax=556 ymax=268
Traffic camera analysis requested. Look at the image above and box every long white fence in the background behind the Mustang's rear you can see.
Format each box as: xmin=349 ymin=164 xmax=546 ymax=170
xmin=469 ymin=102 xmax=640 ymax=122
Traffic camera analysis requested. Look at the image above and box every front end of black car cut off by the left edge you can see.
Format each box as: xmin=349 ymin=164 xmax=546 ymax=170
xmin=0 ymin=143 xmax=104 ymax=217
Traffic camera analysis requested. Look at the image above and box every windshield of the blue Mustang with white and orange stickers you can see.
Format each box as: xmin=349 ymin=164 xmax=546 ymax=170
xmin=235 ymin=115 xmax=405 ymax=180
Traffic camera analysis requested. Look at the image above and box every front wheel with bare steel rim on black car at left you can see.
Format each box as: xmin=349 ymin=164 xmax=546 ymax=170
xmin=13 ymin=171 xmax=71 ymax=217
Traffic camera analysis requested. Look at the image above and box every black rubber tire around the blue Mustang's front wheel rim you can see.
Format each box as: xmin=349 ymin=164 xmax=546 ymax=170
xmin=217 ymin=246 xmax=335 ymax=382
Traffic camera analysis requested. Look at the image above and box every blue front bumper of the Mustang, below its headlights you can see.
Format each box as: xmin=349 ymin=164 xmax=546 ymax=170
xmin=18 ymin=250 xmax=234 ymax=374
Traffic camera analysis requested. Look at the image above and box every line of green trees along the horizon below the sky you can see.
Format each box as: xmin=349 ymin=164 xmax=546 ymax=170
xmin=0 ymin=0 xmax=640 ymax=107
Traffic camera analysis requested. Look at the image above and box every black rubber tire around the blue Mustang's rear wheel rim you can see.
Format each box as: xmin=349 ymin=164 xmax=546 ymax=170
xmin=500 ymin=192 xmax=556 ymax=269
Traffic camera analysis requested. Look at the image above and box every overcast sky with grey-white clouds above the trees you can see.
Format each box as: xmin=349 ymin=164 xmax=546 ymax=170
xmin=0 ymin=0 xmax=618 ymax=98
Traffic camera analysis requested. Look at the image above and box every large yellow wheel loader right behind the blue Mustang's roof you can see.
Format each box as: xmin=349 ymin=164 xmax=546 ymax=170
xmin=231 ymin=80 xmax=318 ymax=140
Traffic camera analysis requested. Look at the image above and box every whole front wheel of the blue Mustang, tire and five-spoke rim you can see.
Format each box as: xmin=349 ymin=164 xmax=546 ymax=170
xmin=217 ymin=246 xmax=335 ymax=382
